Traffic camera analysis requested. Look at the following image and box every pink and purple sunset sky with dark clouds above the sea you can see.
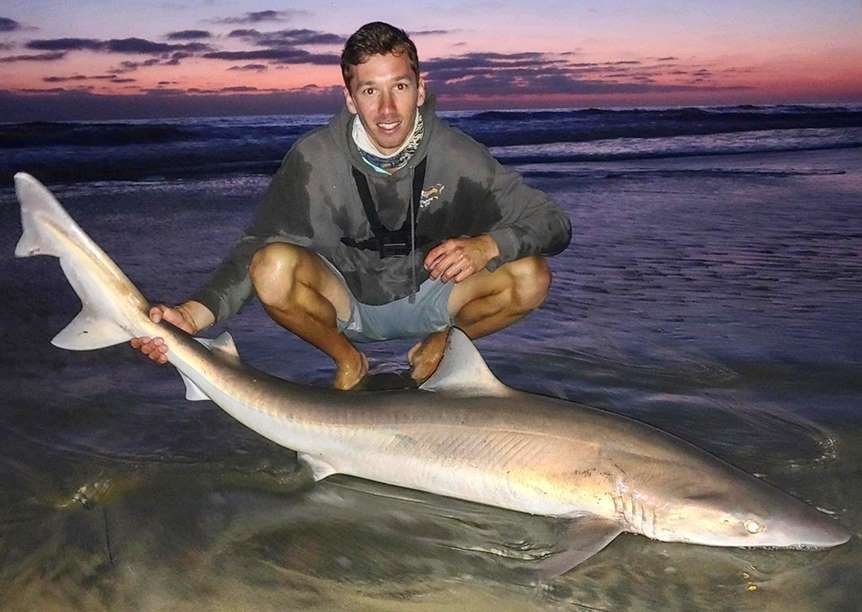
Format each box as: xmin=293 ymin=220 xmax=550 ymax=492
xmin=0 ymin=0 xmax=862 ymax=121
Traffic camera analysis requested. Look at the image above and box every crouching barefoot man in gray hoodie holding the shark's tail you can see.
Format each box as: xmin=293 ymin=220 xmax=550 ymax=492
xmin=132 ymin=22 xmax=571 ymax=389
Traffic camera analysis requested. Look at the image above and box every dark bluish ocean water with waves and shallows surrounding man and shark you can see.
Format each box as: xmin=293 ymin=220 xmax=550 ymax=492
xmin=0 ymin=105 xmax=862 ymax=611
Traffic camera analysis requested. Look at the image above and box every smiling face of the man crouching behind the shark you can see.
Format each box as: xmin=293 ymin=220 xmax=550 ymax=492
xmin=344 ymin=53 xmax=425 ymax=155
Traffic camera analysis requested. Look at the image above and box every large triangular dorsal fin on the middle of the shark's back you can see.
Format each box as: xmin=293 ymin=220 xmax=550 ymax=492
xmin=419 ymin=327 xmax=511 ymax=396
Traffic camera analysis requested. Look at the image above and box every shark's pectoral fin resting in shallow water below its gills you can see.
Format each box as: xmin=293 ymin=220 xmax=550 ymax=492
xmin=537 ymin=516 xmax=623 ymax=580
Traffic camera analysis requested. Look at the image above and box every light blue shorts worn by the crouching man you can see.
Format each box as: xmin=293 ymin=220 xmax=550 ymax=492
xmin=321 ymin=257 xmax=455 ymax=342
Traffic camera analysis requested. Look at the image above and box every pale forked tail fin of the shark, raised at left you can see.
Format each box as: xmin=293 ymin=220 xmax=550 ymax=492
xmin=15 ymin=172 xmax=147 ymax=351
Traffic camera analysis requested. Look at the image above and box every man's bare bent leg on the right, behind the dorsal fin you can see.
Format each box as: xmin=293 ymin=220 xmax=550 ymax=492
xmin=407 ymin=257 xmax=551 ymax=382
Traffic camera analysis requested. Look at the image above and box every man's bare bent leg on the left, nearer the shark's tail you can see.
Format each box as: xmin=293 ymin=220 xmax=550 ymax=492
xmin=249 ymin=243 xmax=368 ymax=389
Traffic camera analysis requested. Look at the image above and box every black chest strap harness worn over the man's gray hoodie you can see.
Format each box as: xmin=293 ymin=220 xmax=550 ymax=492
xmin=341 ymin=158 xmax=431 ymax=257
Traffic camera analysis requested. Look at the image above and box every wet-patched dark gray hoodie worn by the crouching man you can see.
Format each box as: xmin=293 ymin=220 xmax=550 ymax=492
xmin=192 ymin=103 xmax=571 ymax=321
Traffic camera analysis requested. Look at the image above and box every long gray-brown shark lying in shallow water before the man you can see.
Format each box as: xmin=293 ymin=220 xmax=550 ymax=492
xmin=15 ymin=173 xmax=851 ymax=578
